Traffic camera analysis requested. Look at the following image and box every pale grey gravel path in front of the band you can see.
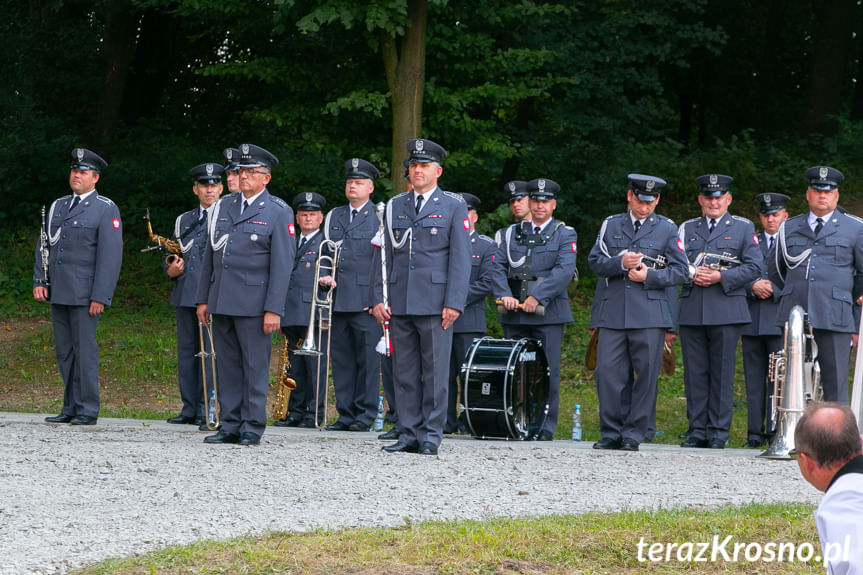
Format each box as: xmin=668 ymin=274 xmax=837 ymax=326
xmin=0 ymin=412 xmax=820 ymax=575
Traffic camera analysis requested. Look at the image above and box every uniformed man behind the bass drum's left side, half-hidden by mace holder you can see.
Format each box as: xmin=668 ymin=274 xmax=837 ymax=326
xmin=444 ymin=194 xmax=509 ymax=433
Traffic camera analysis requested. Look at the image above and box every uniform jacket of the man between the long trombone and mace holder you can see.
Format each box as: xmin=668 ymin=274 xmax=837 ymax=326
xmin=324 ymin=201 xmax=380 ymax=312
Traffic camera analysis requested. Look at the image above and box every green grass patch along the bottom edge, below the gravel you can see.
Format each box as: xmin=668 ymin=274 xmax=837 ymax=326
xmin=80 ymin=504 xmax=821 ymax=575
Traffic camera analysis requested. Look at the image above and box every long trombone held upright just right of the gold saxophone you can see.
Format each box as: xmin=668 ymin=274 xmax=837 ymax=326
xmin=294 ymin=236 xmax=341 ymax=427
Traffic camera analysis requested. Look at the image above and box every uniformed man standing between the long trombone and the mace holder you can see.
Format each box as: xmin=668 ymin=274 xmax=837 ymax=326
xmin=321 ymin=158 xmax=381 ymax=431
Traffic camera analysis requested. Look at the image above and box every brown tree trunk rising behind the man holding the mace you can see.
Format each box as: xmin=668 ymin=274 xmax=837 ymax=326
xmin=381 ymin=0 xmax=428 ymax=194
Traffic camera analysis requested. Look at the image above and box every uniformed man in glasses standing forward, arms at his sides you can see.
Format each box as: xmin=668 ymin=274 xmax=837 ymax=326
xmin=195 ymin=144 xmax=296 ymax=445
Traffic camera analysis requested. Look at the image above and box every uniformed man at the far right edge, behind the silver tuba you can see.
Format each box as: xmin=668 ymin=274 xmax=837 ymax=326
xmin=769 ymin=166 xmax=863 ymax=403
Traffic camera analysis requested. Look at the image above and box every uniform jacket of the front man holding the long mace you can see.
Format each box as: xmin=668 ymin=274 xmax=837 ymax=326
xmin=376 ymin=187 xmax=471 ymax=315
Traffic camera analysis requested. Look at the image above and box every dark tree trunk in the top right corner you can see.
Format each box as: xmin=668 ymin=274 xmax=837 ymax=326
xmin=803 ymin=0 xmax=855 ymax=136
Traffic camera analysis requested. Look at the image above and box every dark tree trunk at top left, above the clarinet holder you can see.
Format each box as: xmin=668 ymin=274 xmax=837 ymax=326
xmin=96 ymin=0 xmax=138 ymax=149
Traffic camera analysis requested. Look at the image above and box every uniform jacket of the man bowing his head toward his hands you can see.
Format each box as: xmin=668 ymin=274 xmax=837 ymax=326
xmin=588 ymin=212 xmax=689 ymax=329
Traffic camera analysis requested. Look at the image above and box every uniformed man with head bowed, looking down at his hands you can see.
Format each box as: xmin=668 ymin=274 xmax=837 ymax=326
xmin=588 ymin=174 xmax=689 ymax=451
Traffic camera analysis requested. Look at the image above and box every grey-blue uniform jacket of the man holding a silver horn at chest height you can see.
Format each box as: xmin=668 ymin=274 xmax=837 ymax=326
xmin=678 ymin=212 xmax=764 ymax=325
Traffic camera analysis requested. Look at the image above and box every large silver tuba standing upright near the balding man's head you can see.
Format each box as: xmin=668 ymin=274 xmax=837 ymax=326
xmin=761 ymin=305 xmax=822 ymax=459
